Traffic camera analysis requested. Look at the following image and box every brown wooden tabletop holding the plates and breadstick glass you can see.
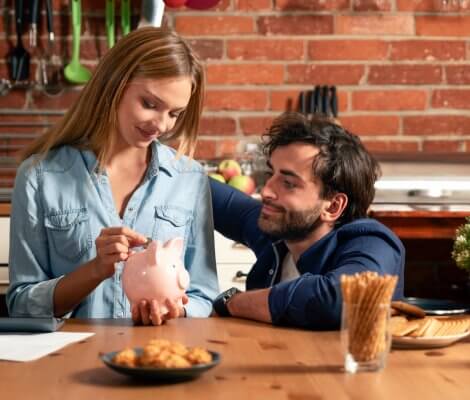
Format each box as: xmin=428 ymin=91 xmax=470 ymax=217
xmin=0 ymin=318 xmax=470 ymax=400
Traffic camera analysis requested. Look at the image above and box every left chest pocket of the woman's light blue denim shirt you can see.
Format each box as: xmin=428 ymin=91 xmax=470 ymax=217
xmin=44 ymin=208 xmax=93 ymax=261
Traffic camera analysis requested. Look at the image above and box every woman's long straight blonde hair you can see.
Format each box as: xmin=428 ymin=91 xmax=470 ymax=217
xmin=20 ymin=27 xmax=204 ymax=167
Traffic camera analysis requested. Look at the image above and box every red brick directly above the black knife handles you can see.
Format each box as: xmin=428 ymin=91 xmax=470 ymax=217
xmin=287 ymin=64 xmax=364 ymax=85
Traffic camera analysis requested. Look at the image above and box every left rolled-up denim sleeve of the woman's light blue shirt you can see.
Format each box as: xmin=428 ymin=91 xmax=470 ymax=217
xmin=6 ymin=163 xmax=60 ymax=317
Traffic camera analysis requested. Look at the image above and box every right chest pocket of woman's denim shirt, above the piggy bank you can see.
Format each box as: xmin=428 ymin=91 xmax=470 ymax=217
xmin=152 ymin=206 xmax=193 ymax=243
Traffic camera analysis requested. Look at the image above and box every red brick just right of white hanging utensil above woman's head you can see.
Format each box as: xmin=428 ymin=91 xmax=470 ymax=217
xmin=175 ymin=15 xmax=255 ymax=36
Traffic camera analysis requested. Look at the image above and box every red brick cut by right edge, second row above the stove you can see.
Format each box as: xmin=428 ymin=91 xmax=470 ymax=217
xmin=403 ymin=115 xmax=470 ymax=135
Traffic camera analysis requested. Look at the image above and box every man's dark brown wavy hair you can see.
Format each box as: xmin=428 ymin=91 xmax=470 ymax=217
xmin=263 ymin=112 xmax=380 ymax=224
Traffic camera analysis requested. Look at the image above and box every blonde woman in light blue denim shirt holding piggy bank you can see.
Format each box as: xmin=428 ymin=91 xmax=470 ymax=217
xmin=7 ymin=27 xmax=218 ymax=325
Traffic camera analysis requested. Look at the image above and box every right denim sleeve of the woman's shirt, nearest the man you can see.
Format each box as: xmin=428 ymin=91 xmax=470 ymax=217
xmin=185 ymin=174 xmax=219 ymax=317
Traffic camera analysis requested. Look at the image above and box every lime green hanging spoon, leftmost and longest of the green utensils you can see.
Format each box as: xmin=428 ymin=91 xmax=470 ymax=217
xmin=64 ymin=0 xmax=91 ymax=84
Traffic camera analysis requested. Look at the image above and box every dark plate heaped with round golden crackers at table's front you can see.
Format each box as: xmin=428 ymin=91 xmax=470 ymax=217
xmin=100 ymin=339 xmax=221 ymax=382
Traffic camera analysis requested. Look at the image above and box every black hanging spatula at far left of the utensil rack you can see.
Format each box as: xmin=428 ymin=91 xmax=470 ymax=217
xmin=8 ymin=0 xmax=30 ymax=82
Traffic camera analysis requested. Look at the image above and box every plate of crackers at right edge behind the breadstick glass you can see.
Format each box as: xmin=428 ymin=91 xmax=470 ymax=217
xmin=390 ymin=301 xmax=470 ymax=349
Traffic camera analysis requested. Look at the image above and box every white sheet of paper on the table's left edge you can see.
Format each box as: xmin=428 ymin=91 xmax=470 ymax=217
xmin=0 ymin=332 xmax=94 ymax=361
